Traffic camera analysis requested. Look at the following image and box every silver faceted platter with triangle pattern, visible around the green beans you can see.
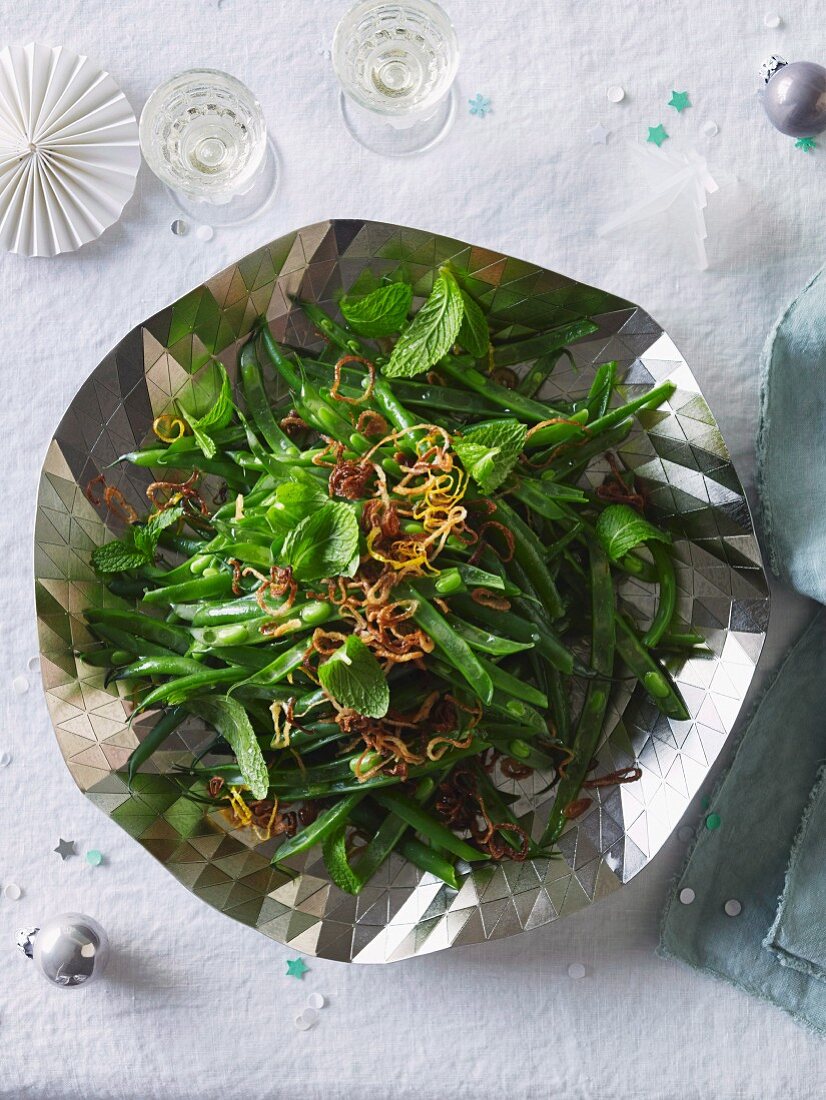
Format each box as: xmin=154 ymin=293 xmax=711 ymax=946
xmin=34 ymin=221 xmax=769 ymax=963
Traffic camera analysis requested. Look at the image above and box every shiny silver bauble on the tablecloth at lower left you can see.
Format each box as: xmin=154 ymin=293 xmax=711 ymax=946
xmin=18 ymin=913 xmax=109 ymax=987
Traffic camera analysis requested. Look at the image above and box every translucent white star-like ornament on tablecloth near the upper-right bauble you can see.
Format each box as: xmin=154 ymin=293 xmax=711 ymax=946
xmin=597 ymin=145 xmax=719 ymax=271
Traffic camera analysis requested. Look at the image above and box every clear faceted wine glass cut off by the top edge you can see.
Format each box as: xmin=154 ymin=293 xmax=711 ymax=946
xmin=332 ymin=0 xmax=459 ymax=156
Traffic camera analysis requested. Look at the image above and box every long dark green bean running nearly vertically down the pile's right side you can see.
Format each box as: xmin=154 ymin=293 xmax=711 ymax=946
xmin=541 ymin=542 xmax=616 ymax=844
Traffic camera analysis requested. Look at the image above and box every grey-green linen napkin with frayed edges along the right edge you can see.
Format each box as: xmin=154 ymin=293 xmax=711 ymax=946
xmin=660 ymin=275 xmax=826 ymax=1034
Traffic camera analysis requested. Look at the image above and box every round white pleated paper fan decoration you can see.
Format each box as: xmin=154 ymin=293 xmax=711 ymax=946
xmin=0 ymin=43 xmax=141 ymax=256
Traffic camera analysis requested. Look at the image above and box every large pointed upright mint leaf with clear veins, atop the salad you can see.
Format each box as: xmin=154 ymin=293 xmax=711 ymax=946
xmin=382 ymin=267 xmax=464 ymax=378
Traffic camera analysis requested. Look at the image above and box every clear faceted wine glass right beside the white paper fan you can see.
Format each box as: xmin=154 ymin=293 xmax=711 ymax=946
xmin=139 ymin=68 xmax=277 ymax=226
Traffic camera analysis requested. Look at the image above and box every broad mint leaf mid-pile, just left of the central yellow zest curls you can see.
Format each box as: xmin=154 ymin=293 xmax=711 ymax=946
xmin=282 ymin=501 xmax=359 ymax=581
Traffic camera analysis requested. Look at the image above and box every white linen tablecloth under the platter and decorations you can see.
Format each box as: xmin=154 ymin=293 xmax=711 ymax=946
xmin=0 ymin=0 xmax=826 ymax=1100
